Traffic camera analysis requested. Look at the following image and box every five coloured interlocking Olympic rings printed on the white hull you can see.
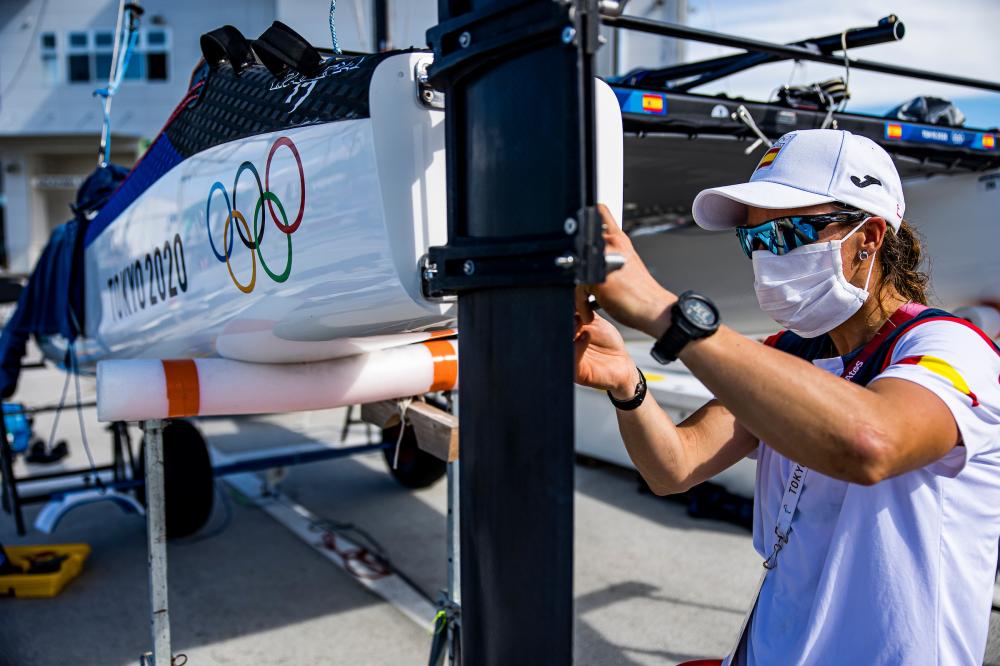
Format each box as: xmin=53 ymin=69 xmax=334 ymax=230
xmin=205 ymin=136 xmax=306 ymax=294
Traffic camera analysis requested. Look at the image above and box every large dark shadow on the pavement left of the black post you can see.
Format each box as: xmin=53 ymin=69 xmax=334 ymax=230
xmin=0 ymin=423 xmax=444 ymax=666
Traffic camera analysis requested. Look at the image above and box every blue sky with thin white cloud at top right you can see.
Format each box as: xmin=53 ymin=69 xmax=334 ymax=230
xmin=684 ymin=0 xmax=1000 ymax=127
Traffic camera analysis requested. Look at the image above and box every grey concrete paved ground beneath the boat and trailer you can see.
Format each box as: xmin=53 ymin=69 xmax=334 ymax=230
xmin=0 ymin=366 xmax=1000 ymax=666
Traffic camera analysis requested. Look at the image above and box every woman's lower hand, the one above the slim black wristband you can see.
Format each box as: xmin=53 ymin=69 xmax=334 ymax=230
xmin=574 ymin=313 xmax=639 ymax=400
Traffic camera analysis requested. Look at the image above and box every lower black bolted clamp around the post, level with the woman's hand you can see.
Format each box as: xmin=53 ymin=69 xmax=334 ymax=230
xmin=421 ymin=202 xmax=615 ymax=298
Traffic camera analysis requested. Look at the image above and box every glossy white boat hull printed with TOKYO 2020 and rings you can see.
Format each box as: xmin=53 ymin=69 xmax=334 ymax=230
xmin=77 ymin=53 xmax=623 ymax=364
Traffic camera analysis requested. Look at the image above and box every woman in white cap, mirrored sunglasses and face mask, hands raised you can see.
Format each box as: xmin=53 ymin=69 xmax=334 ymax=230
xmin=576 ymin=130 xmax=1000 ymax=666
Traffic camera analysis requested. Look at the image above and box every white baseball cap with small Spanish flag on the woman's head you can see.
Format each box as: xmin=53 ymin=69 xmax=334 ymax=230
xmin=691 ymin=130 xmax=906 ymax=231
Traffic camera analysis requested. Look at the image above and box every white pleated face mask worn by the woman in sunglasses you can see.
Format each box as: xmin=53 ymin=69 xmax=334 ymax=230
xmin=753 ymin=218 xmax=875 ymax=338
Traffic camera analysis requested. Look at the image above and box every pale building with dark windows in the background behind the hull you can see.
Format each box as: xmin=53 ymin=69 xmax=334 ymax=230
xmin=0 ymin=0 xmax=686 ymax=273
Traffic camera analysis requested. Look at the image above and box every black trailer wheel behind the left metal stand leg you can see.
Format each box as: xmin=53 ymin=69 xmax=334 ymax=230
xmin=134 ymin=421 xmax=215 ymax=539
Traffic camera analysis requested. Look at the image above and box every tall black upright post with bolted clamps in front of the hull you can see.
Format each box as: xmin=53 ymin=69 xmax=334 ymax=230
xmin=424 ymin=0 xmax=605 ymax=666
